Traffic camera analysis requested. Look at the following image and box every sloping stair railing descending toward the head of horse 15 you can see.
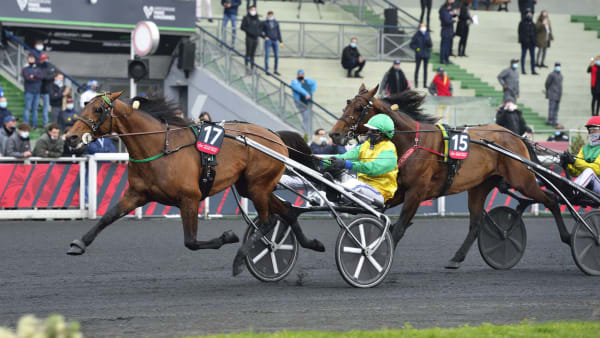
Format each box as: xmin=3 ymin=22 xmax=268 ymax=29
xmin=194 ymin=27 xmax=337 ymax=135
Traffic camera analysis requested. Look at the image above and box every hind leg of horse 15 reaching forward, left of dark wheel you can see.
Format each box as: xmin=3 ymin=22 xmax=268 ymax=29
xmin=445 ymin=180 xmax=494 ymax=269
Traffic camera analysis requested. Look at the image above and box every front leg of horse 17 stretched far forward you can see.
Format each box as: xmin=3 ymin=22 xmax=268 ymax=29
xmin=67 ymin=189 xmax=146 ymax=256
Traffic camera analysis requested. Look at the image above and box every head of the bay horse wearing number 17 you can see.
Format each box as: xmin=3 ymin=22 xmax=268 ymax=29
xmin=64 ymin=91 xmax=123 ymax=150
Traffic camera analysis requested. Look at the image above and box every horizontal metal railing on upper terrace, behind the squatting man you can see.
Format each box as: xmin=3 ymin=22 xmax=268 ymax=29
xmin=201 ymin=18 xmax=417 ymax=61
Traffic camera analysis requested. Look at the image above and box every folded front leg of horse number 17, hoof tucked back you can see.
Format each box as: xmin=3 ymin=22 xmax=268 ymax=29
xmin=179 ymin=199 xmax=240 ymax=251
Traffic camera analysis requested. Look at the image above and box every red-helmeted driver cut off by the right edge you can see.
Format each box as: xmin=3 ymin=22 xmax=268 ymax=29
xmin=561 ymin=116 xmax=600 ymax=194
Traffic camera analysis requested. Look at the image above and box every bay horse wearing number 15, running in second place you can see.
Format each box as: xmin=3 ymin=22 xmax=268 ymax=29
xmin=329 ymin=84 xmax=570 ymax=269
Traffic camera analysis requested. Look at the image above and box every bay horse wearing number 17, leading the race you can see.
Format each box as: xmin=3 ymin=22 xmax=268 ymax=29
xmin=65 ymin=92 xmax=325 ymax=275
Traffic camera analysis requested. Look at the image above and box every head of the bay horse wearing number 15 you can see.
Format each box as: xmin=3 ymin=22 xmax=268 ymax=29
xmin=329 ymin=84 xmax=379 ymax=145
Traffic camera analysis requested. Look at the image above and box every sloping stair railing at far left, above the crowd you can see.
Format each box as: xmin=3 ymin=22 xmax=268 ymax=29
xmin=0 ymin=30 xmax=85 ymax=102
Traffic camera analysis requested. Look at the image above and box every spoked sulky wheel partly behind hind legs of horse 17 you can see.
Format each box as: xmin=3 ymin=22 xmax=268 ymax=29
xmin=244 ymin=218 xmax=298 ymax=282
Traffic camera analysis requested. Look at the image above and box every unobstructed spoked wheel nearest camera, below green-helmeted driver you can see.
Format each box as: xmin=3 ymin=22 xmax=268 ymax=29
xmin=335 ymin=217 xmax=394 ymax=288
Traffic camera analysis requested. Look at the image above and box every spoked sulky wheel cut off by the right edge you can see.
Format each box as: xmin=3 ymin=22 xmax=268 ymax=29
xmin=571 ymin=210 xmax=600 ymax=276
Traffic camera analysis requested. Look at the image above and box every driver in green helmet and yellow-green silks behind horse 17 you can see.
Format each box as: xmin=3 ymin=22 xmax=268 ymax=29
xmin=325 ymin=114 xmax=398 ymax=204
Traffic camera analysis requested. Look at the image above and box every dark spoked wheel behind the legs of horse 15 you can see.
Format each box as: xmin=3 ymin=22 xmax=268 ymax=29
xmin=477 ymin=206 xmax=527 ymax=270
